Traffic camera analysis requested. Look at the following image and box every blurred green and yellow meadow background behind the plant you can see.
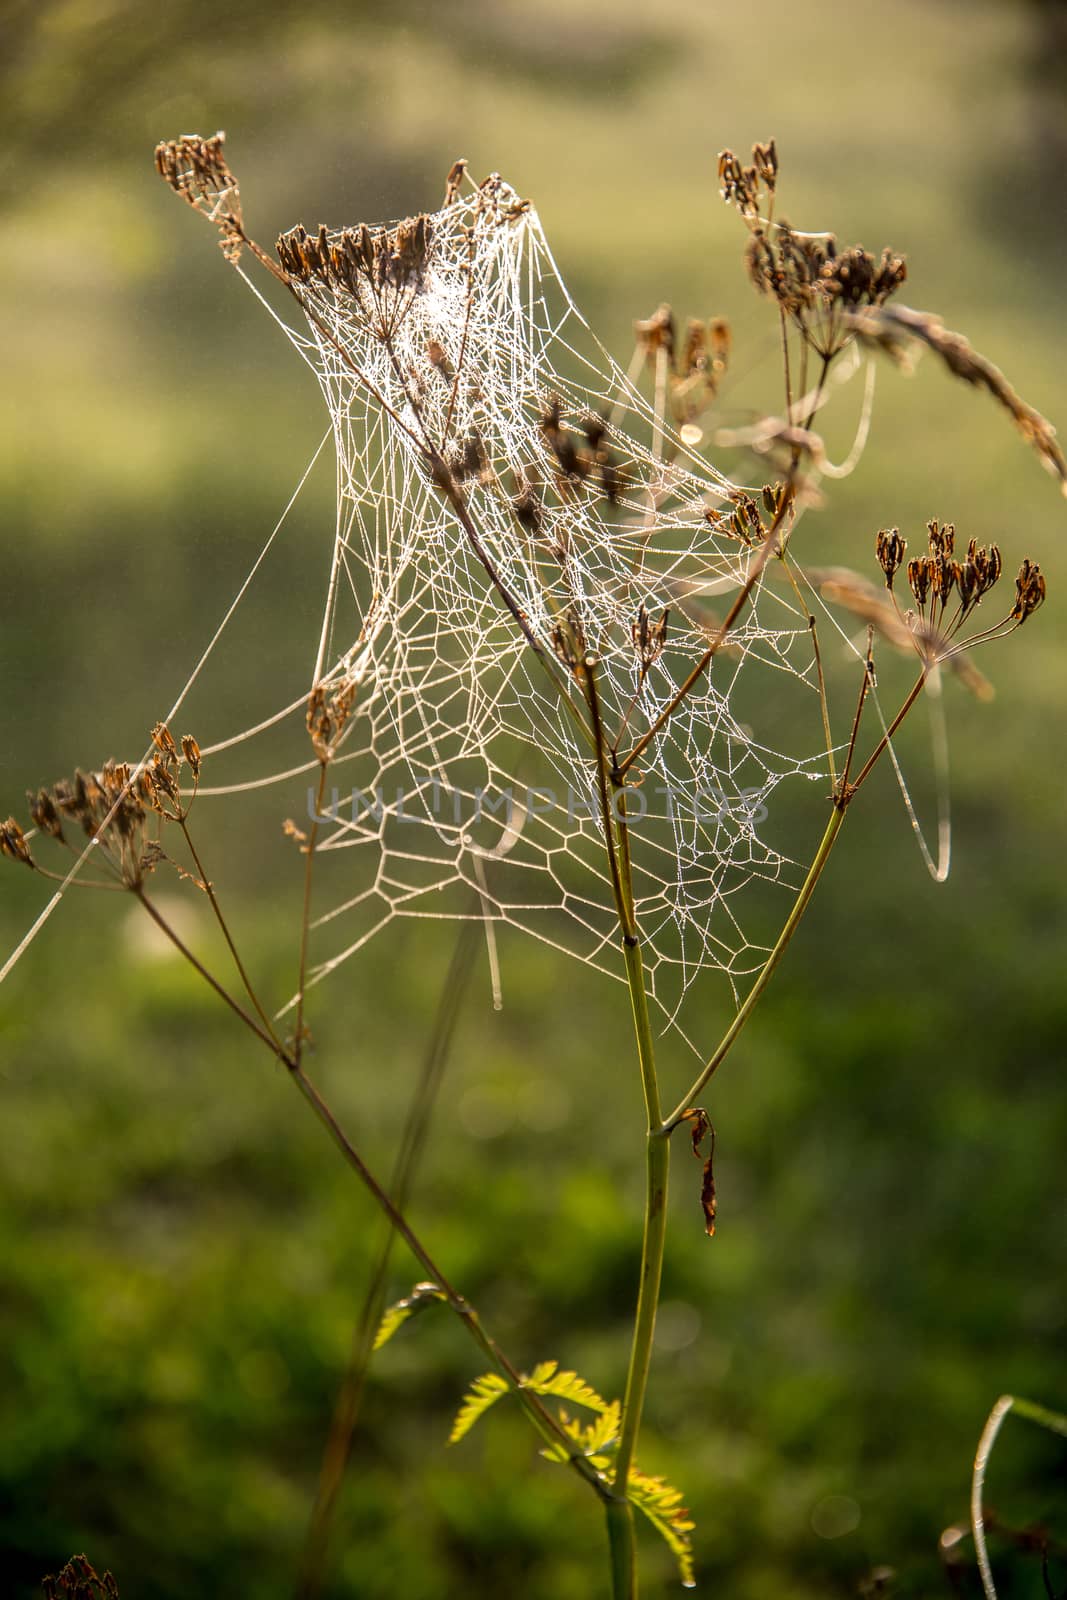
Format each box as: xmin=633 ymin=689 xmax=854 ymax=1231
xmin=0 ymin=0 xmax=1067 ymax=1600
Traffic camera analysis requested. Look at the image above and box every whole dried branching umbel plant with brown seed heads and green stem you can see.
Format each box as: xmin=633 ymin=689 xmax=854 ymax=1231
xmin=8 ymin=134 xmax=1067 ymax=1600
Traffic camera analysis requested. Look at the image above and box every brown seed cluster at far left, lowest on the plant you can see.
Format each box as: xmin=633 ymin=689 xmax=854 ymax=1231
xmin=0 ymin=723 xmax=202 ymax=890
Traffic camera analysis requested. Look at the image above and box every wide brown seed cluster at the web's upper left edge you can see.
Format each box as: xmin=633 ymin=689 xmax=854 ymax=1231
xmin=277 ymin=214 xmax=434 ymax=299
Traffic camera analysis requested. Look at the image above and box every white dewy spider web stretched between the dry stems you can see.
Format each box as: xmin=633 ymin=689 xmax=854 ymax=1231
xmin=241 ymin=168 xmax=825 ymax=1021
